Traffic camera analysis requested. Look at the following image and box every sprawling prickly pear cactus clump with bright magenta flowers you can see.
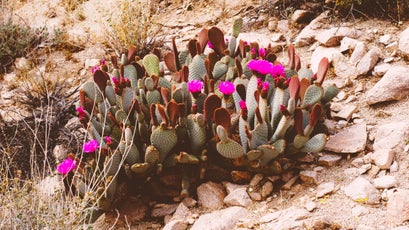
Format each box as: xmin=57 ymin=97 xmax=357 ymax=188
xmin=67 ymin=19 xmax=338 ymax=218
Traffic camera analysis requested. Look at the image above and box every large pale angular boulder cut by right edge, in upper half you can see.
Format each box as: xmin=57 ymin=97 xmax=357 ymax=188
xmin=366 ymin=66 xmax=409 ymax=105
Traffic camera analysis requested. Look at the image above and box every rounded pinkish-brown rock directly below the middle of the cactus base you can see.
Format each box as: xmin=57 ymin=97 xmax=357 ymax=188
xmin=197 ymin=181 xmax=226 ymax=210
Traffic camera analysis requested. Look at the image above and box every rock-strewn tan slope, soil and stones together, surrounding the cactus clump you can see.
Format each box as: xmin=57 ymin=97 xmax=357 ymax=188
xmin=1 ymin=0 xmax=409 ymax=229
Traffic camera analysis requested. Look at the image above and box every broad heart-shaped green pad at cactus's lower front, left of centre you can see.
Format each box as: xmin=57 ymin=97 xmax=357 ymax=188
xmin=151 ymin=127 xmax=178 ymax=163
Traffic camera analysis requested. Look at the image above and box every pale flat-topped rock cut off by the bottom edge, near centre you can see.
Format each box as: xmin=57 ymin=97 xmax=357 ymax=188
xmin=191 ymin=206 xmax=251 ymax=230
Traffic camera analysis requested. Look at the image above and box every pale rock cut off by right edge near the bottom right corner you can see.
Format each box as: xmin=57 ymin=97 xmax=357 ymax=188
xmin=386 ymin=189 xmax=409 ymax=224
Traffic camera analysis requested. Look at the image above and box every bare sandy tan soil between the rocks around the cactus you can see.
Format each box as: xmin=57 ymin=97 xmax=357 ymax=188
xmin=2 ymin=0 xmax=409 ymax=229
